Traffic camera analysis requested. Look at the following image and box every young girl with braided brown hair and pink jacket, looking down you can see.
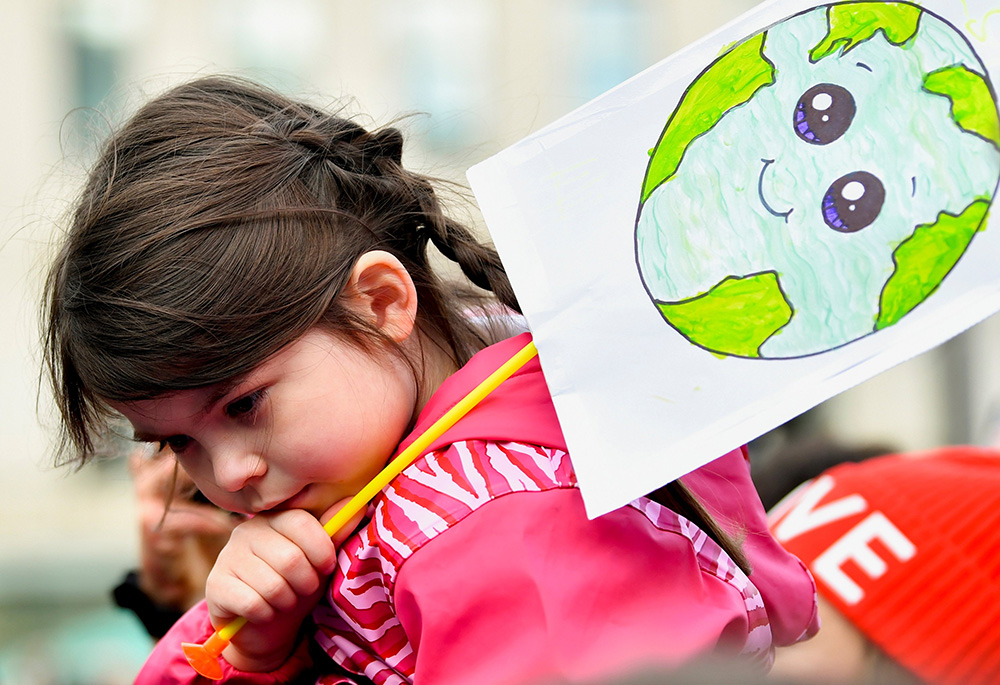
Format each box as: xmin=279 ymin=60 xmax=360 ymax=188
xmin=46 ymin=78 xmax=816 ymax=684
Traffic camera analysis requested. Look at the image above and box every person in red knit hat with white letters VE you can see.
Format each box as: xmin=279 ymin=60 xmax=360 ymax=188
xmin=770 ymin=447 xmax=1000 ymax=685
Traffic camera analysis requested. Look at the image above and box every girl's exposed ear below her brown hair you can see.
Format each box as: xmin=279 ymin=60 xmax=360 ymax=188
xmin=345 ymin=250 xmax=417 ymax=342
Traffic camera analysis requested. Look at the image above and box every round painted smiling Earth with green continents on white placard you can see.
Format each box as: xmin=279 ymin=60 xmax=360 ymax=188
xmin=635 ymin=2 xmax=1000 ymax=358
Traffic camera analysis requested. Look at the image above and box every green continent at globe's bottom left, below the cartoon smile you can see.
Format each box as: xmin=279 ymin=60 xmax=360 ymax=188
xmin=656 ymin=271 xmax=792 ymax=357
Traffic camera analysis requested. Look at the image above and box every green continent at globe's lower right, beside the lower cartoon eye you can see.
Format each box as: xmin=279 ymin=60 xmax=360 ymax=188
xmin=875 ymin=199 xmax=990 ymax=330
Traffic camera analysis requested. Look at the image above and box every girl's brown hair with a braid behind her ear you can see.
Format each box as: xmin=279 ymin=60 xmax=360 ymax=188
xmin=44 ymin=77 xmax=752 ymax=572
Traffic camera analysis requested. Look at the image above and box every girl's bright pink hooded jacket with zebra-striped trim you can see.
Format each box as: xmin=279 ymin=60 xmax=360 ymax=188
xmin=136 ymin=334 xmax=817 ymax=684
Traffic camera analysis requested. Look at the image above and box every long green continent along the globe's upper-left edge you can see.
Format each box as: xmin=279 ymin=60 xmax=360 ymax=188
xmin=642 ymin=33 xmax=774 ymax=202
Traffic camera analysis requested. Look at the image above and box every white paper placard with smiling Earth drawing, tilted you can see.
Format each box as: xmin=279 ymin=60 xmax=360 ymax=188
xmin=468 ymin=0 xmax=1000 ymax=517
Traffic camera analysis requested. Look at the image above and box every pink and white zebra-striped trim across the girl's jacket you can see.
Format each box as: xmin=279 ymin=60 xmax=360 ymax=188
xmin=313 ymin=440 xmax=770 ymax=685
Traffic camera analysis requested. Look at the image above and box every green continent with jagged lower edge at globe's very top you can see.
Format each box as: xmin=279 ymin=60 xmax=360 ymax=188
xmin=809 ymin=2 xmax=922 ymax=62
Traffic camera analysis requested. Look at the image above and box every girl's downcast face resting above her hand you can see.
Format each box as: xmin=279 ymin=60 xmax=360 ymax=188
xmin=113 ymin=329 xmax=417 ymax=518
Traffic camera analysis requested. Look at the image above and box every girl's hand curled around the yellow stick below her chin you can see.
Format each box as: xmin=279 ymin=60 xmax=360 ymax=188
xmin=205 ymin=500 xmax=362 ymax=673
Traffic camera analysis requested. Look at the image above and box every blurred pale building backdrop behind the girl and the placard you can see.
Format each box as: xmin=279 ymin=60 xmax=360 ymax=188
xmin=0 ymin=0 xmax=1000 ymax=685
